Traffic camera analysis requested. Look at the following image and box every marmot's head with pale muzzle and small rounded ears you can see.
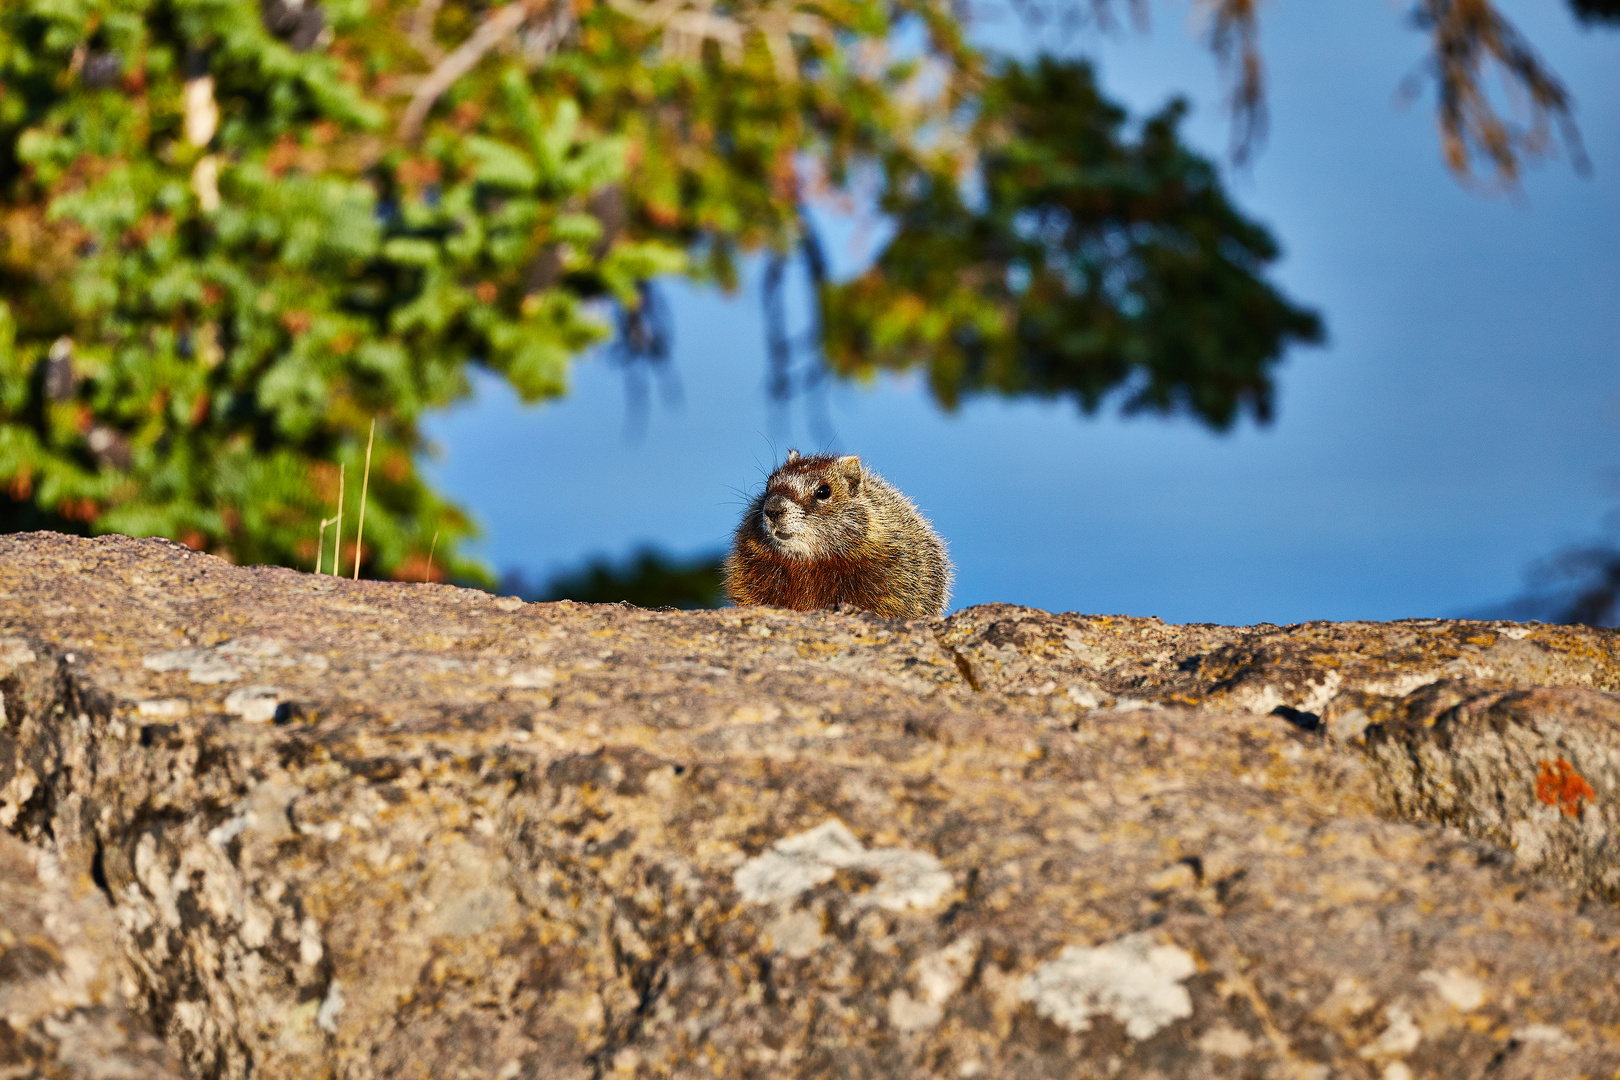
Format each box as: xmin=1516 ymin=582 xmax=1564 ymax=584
xmin=757 ymin=450 xmax=870 ymax=559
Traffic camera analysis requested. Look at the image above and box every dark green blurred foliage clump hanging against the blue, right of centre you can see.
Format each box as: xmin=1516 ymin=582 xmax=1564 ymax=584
xmin=826 ymin=60 xmax=1322 ymax=427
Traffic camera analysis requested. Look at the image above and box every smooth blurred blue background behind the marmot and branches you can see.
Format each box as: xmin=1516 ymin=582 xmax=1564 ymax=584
xmin=428 ymin=0 xmax=1620 ymax=623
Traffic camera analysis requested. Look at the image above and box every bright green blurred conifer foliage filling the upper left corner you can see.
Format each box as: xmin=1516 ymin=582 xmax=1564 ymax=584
xmin=0 ymin=0 xmax=970 ymax=578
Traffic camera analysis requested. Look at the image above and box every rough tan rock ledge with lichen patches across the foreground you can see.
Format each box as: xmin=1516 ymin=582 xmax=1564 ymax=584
xmin=0 ymin=534 xmax=1620 ymax=1080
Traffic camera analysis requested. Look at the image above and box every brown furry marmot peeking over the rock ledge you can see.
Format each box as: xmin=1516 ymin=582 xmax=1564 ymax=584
xmin=726 ymin=450 xmax=951 ymax=619
